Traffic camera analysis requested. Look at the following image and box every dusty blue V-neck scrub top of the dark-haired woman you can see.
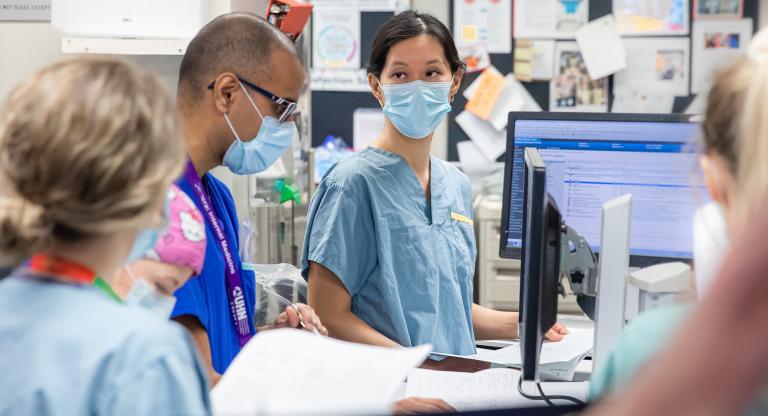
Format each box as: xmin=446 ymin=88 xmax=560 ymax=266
xmin=302 ymin=147 xmax=477 ymax=355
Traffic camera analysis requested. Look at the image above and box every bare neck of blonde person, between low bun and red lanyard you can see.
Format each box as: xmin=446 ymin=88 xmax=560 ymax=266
xmin=45 ymin=236 xmax=132 ymax=284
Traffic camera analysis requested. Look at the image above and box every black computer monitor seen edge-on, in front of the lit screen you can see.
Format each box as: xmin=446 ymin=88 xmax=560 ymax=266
xmin=518 ymin=148 xmax=562 ymax=380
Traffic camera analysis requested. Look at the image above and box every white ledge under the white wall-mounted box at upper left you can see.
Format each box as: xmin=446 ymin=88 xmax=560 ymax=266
xmin=61 ymin=36 xmax=190 ymax=55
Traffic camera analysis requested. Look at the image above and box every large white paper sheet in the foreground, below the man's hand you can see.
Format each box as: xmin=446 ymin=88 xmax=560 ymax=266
xmin=211 ymin=329 xmax=431 ymax=415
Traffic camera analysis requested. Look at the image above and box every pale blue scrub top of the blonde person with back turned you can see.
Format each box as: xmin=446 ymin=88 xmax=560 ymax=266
xmin=0 ymin=274 xmax=211 ymax=416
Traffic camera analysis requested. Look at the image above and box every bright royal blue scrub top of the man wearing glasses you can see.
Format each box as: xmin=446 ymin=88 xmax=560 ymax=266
xmin=171 ymin=173 xmax=256 ymax=374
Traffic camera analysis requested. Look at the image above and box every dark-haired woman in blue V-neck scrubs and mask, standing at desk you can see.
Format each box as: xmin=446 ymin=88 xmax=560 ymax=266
xmin=302 ymin=12 xmax=567 ymax=355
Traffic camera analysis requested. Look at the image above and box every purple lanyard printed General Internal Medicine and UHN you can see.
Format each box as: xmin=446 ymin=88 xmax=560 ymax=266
xmin=184 ymin=161 xmax=253 ymax=347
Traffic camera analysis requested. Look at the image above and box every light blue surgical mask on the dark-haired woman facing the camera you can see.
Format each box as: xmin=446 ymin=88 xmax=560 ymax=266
xmin=379 ymin=81 xmax=453 ymax=139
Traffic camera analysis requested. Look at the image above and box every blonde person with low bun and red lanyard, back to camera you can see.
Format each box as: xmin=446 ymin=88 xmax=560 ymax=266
xmin=0 ymin=58 xmax=210 ymax=415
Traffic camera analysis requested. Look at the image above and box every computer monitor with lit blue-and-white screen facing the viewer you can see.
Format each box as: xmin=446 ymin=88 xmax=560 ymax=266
xmin=500 ymin=112 xmax=707 ymax=267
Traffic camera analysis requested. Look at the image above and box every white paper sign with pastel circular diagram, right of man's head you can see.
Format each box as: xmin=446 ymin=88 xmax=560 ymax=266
xmin=312 ymin=8 xmax=360 ymax=69
